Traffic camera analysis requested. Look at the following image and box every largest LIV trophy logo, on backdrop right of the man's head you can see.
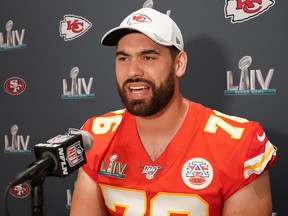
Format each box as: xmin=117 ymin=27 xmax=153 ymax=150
xmin=224 ymin=56 xmax=276 ymax=95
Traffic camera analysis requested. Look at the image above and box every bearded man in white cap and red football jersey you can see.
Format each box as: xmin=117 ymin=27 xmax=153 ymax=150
xmin=71 ymin=3 xmax=276 ymax=216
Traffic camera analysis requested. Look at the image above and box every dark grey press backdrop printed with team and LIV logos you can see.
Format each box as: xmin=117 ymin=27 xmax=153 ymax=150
xmin=0 ymin=0 xmax=288 ymax=215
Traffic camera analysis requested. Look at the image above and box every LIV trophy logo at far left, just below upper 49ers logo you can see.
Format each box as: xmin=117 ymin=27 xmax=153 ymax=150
xmin=4 ymin=125 xmax=31 ymax=153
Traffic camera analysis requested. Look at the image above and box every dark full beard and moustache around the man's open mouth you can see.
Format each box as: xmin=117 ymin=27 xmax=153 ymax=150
xmin=117 ymin=66 xmax=175 ymax=117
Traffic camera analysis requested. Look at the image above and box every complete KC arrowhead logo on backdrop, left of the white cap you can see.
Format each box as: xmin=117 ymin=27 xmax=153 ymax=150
xmin=59 ymin=14 xmax=92 ymax=41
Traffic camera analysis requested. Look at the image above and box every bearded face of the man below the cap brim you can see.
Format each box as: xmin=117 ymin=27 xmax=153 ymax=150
xmin=116 ymin=33 xmax=175 ymax=117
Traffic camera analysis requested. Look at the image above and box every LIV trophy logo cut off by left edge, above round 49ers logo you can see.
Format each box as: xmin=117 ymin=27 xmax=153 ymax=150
xmin=0 ymin=20 xmax=27 ymax=51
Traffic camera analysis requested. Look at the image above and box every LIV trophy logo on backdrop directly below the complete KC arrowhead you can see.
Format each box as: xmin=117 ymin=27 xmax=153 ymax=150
xmin=62 ymin=67 xmax=95 ymax=99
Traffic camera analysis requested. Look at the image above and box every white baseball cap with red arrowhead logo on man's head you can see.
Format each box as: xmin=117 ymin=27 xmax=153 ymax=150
xmin=101 ymin=8 xmax=184 ymax=51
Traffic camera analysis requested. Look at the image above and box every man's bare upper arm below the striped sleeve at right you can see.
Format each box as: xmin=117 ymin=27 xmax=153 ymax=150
xmin=222 ymin=170 xmax=272 ymax=216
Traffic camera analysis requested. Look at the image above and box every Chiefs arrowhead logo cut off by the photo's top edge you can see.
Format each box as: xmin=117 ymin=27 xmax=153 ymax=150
xmin=224 ymin=0 xmax=275 ymax=23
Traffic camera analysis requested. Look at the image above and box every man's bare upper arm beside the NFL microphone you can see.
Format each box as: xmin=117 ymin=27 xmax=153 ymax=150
xmin=70 ymin=169 xmax=109 ymax=216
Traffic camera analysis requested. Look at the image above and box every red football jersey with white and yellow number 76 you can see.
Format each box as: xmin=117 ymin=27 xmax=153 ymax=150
xmin=82 ymin=101 xmax=276 ymax=216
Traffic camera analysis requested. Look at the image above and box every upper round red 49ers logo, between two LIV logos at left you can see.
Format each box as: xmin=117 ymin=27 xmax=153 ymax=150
xmin=4 ymin=77 xmax=26 ymax=95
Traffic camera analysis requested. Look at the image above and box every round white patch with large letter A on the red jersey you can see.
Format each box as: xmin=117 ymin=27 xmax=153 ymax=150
xmin=182 ymin=158 xmax=213 ymax=190
